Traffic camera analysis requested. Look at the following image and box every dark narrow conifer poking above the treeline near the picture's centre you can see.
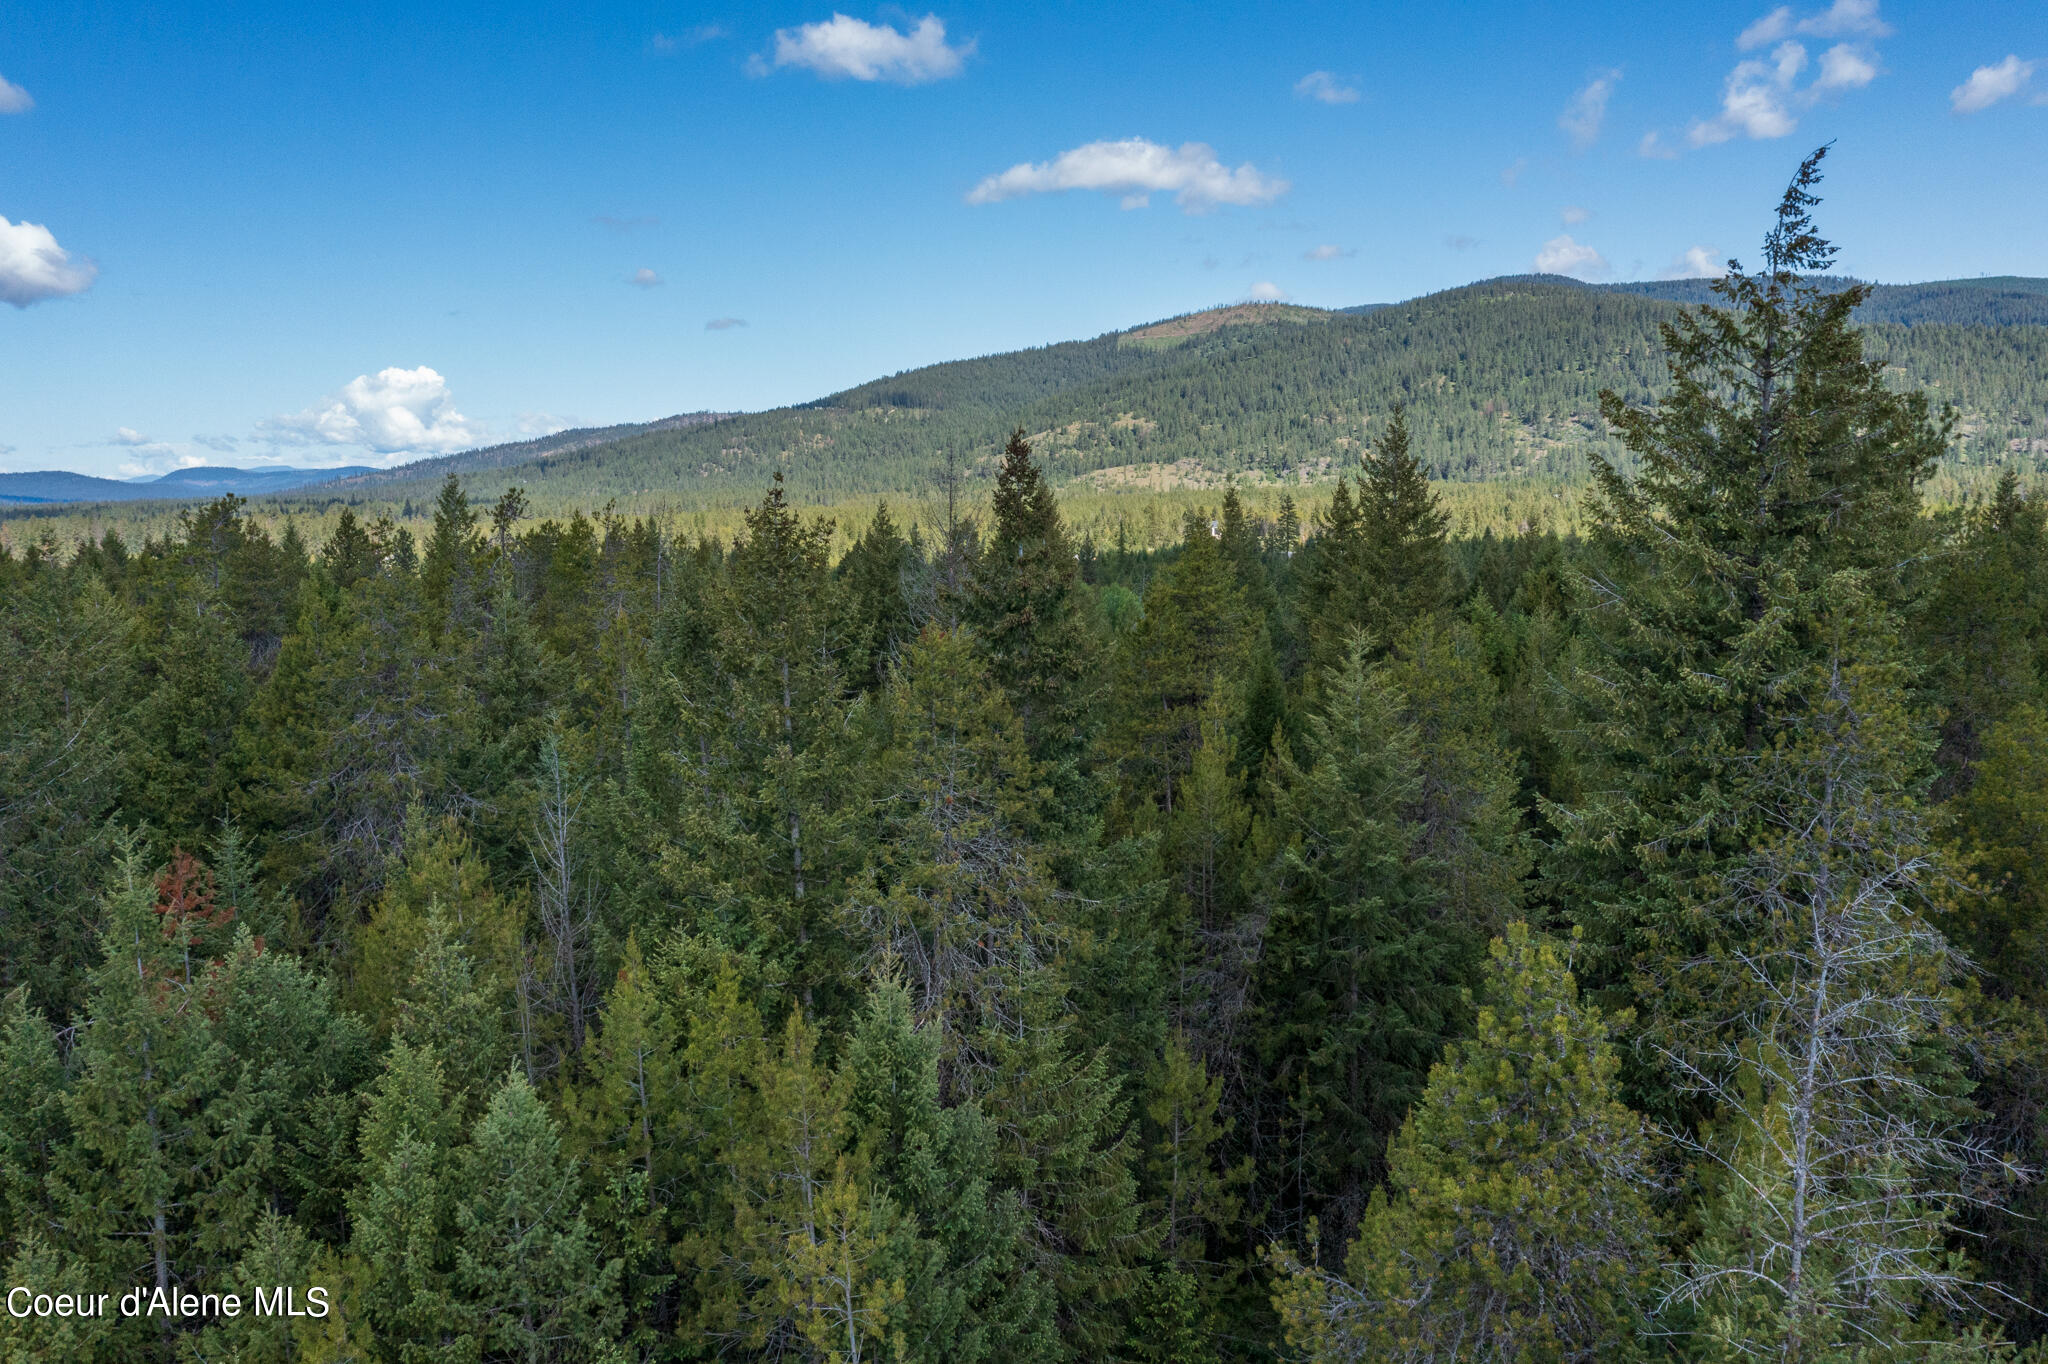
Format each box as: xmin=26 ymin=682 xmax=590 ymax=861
xmin=963 ymin=428 xmax=1094 ymax=764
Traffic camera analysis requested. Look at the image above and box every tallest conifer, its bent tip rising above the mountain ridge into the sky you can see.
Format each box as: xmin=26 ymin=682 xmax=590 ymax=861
xmin=1548 ymin=150 xmax=1946 ymax=1081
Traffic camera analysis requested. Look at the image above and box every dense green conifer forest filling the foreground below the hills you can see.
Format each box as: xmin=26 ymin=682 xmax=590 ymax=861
xmin=12 ymin=154 xmax=2048 ymax=1364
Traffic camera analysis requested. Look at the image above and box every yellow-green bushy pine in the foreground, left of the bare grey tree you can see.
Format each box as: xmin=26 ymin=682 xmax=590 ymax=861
xmin=1272 ymin=924 xmax=1663 ymax=1364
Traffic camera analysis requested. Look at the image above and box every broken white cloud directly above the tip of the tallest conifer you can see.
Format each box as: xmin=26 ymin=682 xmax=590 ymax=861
xmin=1695 ymin=0 xmax=1892 ymax=146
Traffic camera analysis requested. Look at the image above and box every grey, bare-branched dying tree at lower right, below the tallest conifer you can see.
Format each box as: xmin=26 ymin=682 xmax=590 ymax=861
xmin=1663 ymin=657 xmax=2019 ymax=1362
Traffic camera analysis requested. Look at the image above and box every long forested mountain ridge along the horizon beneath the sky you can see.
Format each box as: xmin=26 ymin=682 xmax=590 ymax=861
xmin=0 ymin=274 xmax=2048 ymax=514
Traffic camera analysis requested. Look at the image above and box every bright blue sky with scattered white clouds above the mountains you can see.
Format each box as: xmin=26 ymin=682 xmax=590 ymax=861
xmin=0 ymin=0 xmax=2048 ymax=477
